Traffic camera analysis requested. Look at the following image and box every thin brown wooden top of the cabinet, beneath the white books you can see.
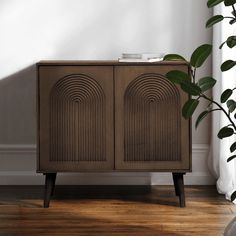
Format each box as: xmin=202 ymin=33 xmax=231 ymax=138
xmin=37 ymin=60 xmax=188 ymax=66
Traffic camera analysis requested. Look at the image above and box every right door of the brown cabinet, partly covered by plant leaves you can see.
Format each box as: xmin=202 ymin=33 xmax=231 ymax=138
xmin=115 ymin=63 xmax=191 ymax=171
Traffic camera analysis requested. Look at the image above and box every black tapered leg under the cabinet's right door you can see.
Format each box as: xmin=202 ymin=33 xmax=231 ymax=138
xmin=172 ymin=173 xmax=185 ymax=207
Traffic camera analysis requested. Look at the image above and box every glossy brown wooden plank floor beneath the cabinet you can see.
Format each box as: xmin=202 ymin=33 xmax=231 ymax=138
xmin=0 ymin=186 xmax=236 ymax=236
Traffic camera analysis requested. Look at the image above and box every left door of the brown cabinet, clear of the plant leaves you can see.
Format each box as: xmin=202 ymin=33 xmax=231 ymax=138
xmin=38 ymin=65 xmax=114 ymax=172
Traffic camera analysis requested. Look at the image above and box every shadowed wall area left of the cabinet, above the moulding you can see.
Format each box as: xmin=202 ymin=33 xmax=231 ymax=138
xmin=0 ymin=64 xmax=36 ymax=144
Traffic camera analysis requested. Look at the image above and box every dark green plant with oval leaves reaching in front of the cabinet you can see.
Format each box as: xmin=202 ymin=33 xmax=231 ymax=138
xmin=164 ymin=0 xmax=236 ymax=201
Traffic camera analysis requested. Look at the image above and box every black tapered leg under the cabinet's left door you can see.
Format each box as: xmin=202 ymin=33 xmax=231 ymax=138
xmin=44 ymin=173 xmax=56 ymax=208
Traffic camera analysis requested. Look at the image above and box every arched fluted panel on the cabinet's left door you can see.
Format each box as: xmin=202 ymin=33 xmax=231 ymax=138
xmin=50 ymin=74 xmax=106 ymax=162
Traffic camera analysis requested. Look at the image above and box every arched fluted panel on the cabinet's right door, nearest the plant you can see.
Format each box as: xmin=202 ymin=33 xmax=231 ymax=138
xmin=124 ymin=73 xmax=181 ymax=161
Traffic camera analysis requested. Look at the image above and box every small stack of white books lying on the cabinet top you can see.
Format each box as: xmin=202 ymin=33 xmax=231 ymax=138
xmin=119 ymin=53 xmax=164 ymax=62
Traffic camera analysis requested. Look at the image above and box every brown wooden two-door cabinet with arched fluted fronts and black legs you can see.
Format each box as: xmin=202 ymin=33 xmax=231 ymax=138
xmin=37 ymin=61 xmax=191 ymax=207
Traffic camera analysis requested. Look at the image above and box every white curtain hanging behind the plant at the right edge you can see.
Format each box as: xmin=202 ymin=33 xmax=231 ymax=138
xmin=208 ymin=4 xmax=236 ymax=203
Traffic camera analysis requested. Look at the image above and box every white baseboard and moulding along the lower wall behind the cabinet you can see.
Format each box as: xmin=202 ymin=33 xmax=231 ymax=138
xmin=0 ymin=144 xmax=215 ymax=185
